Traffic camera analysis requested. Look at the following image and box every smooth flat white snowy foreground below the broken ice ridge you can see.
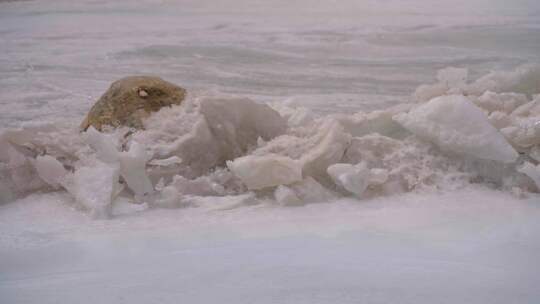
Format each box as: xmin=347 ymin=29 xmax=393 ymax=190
xmin=0 ymin=188 xmax=540 ymax=304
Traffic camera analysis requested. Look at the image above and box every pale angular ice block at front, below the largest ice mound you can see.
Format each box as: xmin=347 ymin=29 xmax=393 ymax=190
xmin=227 ymin=154 xmax=302 ymax=189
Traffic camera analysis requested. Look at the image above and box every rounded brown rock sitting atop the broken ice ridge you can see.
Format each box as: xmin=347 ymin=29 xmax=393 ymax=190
xmin=81 ymin=76 xmax=186 ymax=131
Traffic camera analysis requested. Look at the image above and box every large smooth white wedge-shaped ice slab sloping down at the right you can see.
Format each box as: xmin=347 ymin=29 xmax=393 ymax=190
xmin=394 ymin=95 xmax=518 ymax=163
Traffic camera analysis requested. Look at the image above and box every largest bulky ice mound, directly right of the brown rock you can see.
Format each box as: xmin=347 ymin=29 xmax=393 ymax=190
xmin=132 ymin=96 xmax=287 ymax=178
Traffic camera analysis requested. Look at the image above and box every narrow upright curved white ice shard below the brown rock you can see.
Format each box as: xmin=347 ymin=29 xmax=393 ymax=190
xmin=119 ymin=141 xmax=154 ymax=196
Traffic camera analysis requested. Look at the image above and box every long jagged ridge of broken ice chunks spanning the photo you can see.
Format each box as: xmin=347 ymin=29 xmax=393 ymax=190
xmin=0 ymin=67 xmax=540 ymax=217
